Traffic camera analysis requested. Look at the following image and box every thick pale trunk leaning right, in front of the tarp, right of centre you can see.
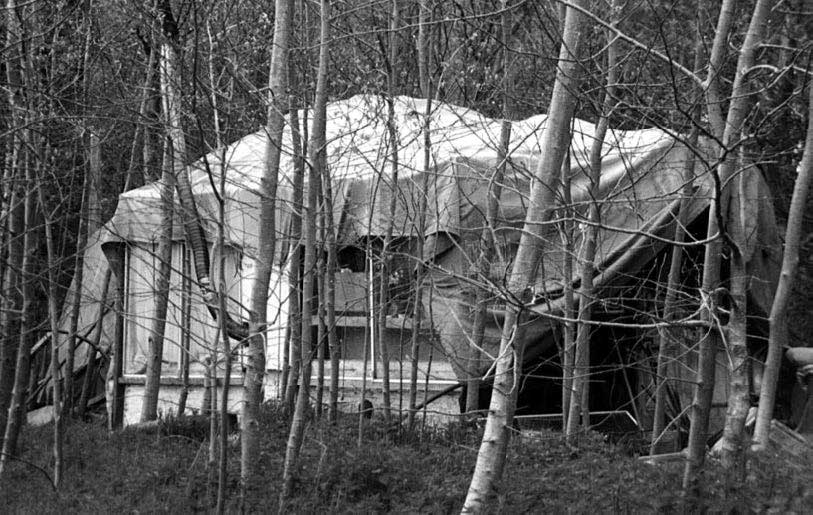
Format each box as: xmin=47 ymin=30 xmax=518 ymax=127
xmin=463 ymin=1 xmax=582 ymax=513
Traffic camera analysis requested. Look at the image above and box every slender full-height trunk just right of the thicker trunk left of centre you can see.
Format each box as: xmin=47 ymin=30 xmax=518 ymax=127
xmin=279 ymin=0 xmax=330 ymax=500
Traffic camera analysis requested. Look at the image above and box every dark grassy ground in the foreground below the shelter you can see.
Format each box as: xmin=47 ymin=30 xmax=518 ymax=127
xmin=0 ymin=408 xmax=813 ymax=513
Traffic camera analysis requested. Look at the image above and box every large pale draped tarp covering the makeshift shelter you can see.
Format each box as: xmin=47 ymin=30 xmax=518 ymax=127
xmin=57 ymin=95 xmax=781 ymax=408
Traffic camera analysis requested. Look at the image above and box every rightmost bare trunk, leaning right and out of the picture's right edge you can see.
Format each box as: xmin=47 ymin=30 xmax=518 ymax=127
xmin=753 ymin=70 xmax=813 ymax=451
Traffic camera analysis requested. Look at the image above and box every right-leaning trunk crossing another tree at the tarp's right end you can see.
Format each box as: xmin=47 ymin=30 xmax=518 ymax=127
xmin=683 ymin=0 xmax=771 ymax=493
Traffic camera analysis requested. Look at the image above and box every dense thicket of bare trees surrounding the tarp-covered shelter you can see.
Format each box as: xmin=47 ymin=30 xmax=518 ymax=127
xmin=0 ymin=0 xmax=813 ymax=511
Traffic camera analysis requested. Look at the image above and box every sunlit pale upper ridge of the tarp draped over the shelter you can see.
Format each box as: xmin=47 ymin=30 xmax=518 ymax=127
xmin=98 ymin=95 xmax=674 ymax=256
